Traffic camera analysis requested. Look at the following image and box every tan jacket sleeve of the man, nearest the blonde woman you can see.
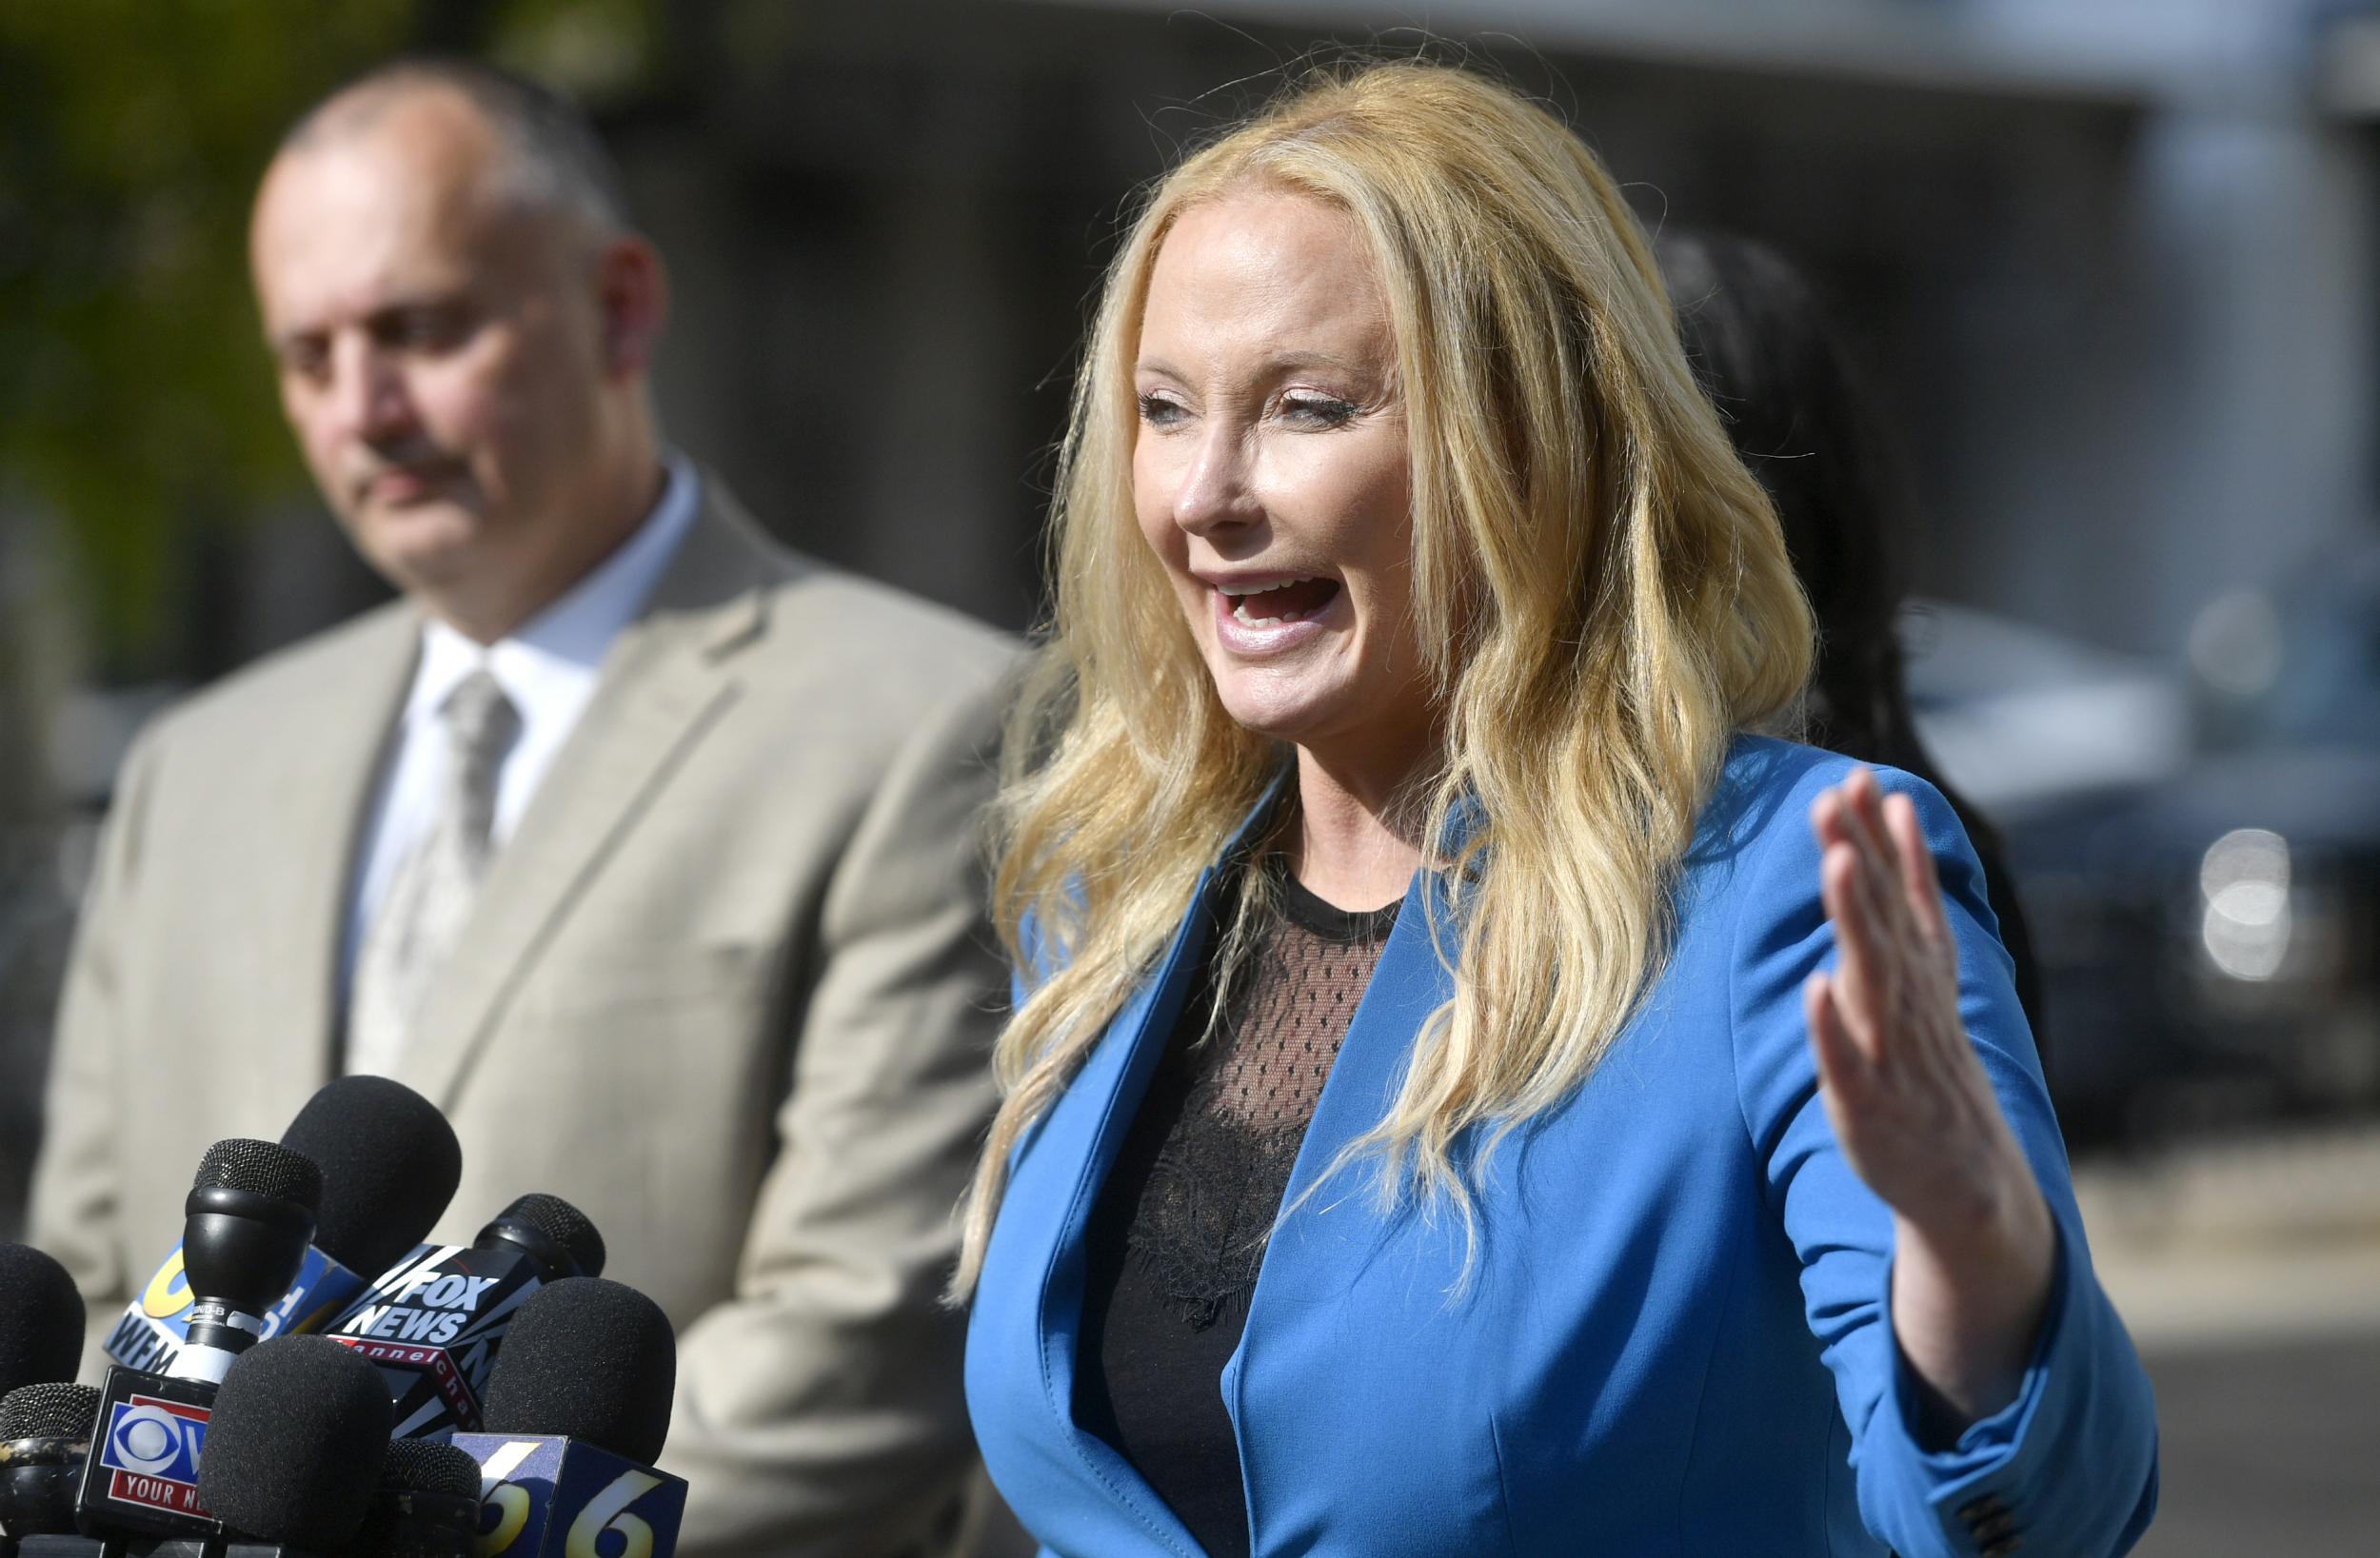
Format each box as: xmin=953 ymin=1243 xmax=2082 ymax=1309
xmin=666 ymin=675 xmax=1002 ymax=1558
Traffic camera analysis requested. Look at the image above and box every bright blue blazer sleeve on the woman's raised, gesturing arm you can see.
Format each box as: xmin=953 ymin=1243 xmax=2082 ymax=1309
xmin=1733 ymin=771 xmax=2156 ymax=1558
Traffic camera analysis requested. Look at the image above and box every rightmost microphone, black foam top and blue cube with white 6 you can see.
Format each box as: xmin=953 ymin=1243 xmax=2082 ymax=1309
xmin=455 ymin=1277 xmax=685 ymax=1558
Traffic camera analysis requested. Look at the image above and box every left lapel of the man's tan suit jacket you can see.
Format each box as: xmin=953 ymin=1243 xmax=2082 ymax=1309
xmin=241 ymin=604 xmax=422 ymax=1120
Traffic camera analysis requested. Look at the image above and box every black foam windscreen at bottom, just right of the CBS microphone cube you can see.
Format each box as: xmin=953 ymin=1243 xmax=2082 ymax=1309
xmin=198 ymin=1337 xmax=390 ymax=1551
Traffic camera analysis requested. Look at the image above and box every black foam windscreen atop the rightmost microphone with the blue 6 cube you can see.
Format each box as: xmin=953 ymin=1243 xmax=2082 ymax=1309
xmin=481 ymin=1277 xmax=679 ymax=1466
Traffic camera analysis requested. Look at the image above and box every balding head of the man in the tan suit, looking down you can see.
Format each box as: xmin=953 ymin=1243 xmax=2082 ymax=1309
xmin=250 ymin=67 xmax=666 ymax=642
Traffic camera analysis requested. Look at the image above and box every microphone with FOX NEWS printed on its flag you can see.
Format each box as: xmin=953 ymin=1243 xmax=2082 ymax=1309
xmin=328 ymin=1194 xmax=605 ymax=1439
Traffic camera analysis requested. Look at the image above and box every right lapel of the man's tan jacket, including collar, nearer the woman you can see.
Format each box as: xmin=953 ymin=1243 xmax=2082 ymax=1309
xmin=398 ymin=481 xmax=793 ymax=1109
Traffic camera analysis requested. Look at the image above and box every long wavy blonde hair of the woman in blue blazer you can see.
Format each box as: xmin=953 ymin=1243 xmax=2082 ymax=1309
xmin=952 ymin=62 xmax=1812 ymax=1299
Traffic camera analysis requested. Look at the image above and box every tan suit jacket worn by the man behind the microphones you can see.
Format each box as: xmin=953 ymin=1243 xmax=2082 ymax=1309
xmin=33 ymin=483 xmax=1014 ymax=1556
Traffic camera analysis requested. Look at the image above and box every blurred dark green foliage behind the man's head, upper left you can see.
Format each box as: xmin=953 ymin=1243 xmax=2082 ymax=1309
xmin=0 ymin=0 xmax=662 ymax=671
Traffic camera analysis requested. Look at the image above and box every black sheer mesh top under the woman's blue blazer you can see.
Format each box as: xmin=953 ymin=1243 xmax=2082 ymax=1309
xmin=1074 ymin=857 xmax=1398 ymax=1556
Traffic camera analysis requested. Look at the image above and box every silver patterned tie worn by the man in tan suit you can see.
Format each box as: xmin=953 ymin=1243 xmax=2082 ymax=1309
xmin=347 ymin=671 xmax=522 ymax=1075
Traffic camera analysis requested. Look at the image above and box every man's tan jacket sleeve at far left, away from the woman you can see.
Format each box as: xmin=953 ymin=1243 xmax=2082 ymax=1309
xmin=27 ymin=728 xmax=160 ymax=1372
